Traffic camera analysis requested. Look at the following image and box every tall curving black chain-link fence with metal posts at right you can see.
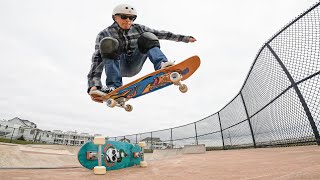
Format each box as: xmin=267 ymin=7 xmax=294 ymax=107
xmin=109 ymin=2 xmax=320 ymax=149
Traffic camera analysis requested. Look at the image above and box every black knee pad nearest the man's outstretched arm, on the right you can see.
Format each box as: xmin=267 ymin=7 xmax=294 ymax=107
xmin=138 ymin=32 xmax=160 ymax=54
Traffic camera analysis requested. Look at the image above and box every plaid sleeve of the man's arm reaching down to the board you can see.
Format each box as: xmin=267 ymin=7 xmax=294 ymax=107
xmin=87 ymin=33 xmax=104 ymax=93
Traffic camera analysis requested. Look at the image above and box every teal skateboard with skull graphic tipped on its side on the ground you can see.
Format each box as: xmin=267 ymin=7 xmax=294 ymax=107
xmin=78 ymin=137 xmax=147 ymax=174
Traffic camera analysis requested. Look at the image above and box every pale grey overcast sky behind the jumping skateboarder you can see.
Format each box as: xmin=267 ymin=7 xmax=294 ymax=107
xmin=0 ymin=0 xmax=318 ymax=136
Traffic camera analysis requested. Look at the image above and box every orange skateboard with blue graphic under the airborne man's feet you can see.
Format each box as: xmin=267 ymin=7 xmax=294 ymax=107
xmin=90 ymin=56 xmax=200 ymax=112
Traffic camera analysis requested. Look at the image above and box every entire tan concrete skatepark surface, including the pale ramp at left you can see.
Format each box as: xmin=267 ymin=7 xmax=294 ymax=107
xmin=0 ymin=143 xmax=320 ymax=180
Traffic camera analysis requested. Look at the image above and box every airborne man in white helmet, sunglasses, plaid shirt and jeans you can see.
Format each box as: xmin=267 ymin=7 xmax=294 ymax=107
xmin=87 ymin=4 xmax=196 ymax=103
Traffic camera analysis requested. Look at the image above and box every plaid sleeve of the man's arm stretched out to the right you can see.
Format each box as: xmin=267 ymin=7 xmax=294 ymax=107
xmin=141 ymin=25 xmax=191 ymax=43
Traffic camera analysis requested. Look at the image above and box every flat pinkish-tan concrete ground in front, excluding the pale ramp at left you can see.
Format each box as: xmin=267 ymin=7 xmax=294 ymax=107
xmin=0 ymin=146 xmax=320 ymax=180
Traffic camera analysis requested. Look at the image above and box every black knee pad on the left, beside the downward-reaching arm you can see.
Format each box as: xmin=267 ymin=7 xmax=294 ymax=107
xmin=100 ymin=37 xmax=120 ymax=59
